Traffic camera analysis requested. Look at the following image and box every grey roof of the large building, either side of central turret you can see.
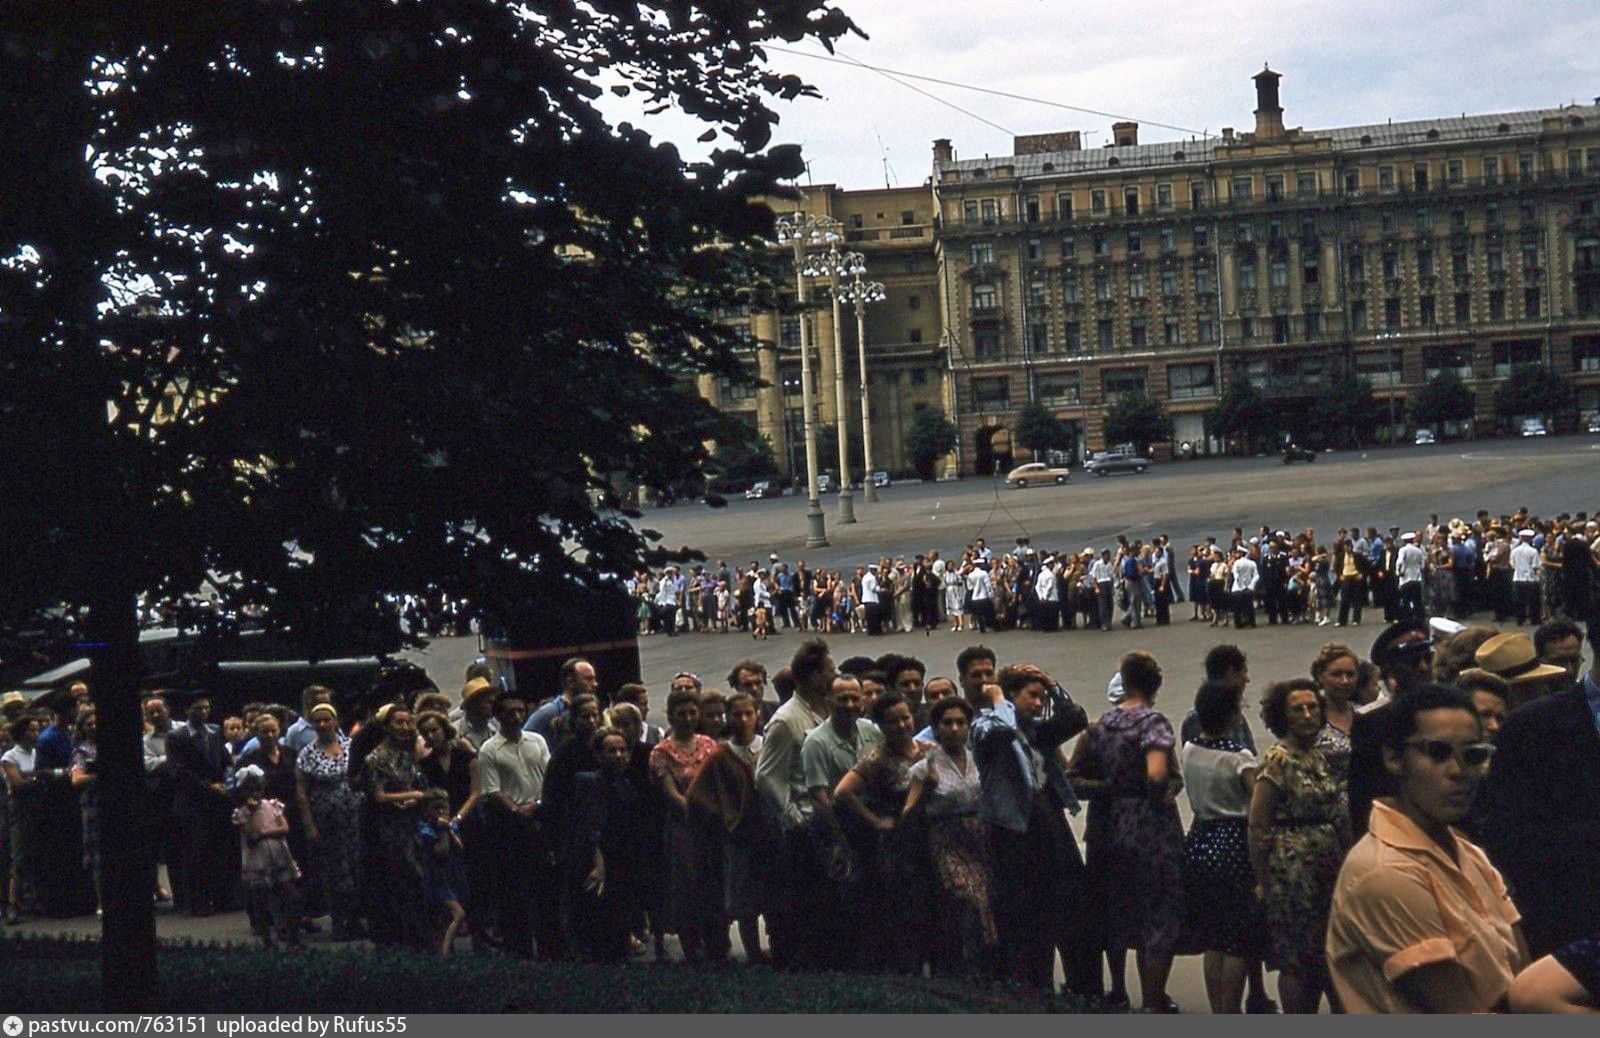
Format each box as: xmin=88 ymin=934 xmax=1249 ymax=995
xmin=938 ymin=104 xmax=1600 ymax=179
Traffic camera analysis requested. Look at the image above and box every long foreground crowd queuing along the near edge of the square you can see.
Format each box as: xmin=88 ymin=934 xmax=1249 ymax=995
xmin=0 ymin=598 xmax=1600 ymax=1012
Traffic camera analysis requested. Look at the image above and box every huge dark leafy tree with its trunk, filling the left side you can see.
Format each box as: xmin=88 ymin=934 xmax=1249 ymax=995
xmin=0 ymin=0 xmax=851 ymax=1011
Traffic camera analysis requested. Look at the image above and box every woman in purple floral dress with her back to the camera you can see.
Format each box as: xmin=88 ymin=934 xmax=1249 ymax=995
xmin=1070 ymin=653 xmax=1184 ymax=1012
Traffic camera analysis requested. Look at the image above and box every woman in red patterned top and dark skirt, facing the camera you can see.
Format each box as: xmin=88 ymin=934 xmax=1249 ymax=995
xmin=650 ymin=689 xmax=728 ymax=963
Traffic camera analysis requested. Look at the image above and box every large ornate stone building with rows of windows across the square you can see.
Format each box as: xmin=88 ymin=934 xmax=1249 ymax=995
xmin=707 ymin=70 xmax=1600 ymax=473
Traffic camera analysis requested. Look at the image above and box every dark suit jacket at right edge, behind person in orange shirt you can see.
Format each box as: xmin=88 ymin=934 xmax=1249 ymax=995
xmin=1485 ymin=685 xmax=1600 ymax=956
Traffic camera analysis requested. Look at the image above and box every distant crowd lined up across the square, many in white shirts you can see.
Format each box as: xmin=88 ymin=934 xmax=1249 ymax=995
xmin=627 ymin=509 xmax=1600 ymax=638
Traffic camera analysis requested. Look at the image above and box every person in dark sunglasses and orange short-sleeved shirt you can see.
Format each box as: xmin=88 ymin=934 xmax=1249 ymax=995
xmin=1326 ymin=685 xmax=1528 ymax=1012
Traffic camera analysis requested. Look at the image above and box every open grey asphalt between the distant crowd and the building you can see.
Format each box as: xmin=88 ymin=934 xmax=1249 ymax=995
xmin=637 ymin=435 xmax=1600 ymax=568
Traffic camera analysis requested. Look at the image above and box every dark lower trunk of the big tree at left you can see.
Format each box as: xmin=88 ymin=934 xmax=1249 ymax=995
xmin=88 ymin=574 xmax=158 ymax=1012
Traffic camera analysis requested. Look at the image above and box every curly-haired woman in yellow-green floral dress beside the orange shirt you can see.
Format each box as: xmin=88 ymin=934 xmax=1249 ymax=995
xmin=1250 ymin=678 xmax=1350 ymax=1012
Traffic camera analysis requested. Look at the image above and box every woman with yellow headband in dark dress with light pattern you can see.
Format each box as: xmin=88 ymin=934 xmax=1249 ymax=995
xmin=294 ymin=702 xmax=362 ymax=940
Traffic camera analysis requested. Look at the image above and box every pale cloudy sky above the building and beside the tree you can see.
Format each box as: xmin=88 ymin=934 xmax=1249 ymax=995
xmin=606 ymin=0 xmax=1600 ymax=189
